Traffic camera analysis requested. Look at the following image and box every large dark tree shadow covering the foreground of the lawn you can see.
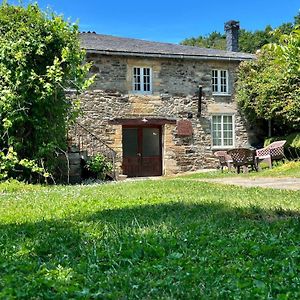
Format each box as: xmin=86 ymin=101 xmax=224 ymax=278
xmin=0 ymin=202 xmax=300 ymax=299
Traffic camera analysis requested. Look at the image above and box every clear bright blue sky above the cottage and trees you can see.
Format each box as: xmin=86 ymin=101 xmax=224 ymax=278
xmin=8 ymin=0 xmax=300 ymax=43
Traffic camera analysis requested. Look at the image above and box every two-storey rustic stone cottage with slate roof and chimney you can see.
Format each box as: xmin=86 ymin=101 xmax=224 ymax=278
xmin=72 ymin=21 xmax=254 ymax=177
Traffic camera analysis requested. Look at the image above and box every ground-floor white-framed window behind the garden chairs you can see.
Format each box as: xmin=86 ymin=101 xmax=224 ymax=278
xmin=211 ymin=115 xmax=235 ymax=148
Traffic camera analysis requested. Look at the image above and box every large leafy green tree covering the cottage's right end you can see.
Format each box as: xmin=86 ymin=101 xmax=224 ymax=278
xmin=237 ymin=26 xmax=300 ymax=134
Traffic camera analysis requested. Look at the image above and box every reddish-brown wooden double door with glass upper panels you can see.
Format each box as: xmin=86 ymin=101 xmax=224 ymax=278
xmin=122 ymin=126 xmax=162 ymax=177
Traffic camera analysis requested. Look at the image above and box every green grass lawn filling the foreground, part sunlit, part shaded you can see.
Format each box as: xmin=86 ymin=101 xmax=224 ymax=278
xmin=0 ymin=169 xmax=300 ymax=299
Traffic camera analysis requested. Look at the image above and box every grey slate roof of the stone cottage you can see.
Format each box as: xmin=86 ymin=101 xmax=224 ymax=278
xmin=80 ymin=33 xmax=255 ymax=61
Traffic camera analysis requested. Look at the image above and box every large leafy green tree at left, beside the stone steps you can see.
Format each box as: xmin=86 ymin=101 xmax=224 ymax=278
xmin=0 ymin=3 xmax=91 ymax=180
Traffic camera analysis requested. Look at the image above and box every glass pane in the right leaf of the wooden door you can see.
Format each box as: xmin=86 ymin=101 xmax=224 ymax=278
xmin=143 ymin=128 xmax=160 ymax=156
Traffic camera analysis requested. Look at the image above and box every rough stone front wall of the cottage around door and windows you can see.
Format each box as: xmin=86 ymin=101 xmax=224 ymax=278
xmin=71 ymin=54 xmax=251 ymax=174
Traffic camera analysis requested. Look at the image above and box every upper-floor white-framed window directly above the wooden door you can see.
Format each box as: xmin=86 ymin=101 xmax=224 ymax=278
xmin=132 ymin=67 xmax=152 ymax=94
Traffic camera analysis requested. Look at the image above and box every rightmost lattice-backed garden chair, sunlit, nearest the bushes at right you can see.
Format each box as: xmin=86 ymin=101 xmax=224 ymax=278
xmin=256 ymin=140 xmax=286 ymax=168
